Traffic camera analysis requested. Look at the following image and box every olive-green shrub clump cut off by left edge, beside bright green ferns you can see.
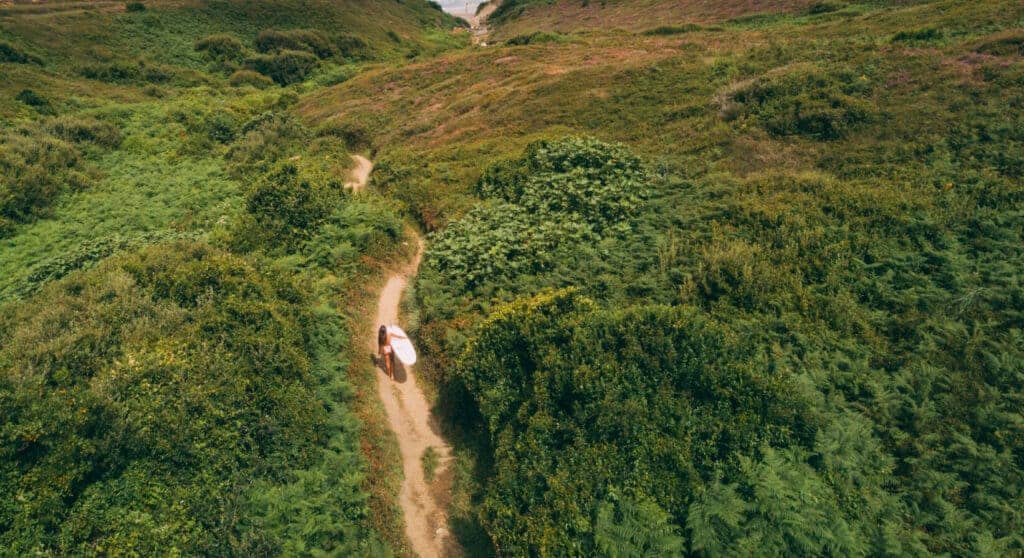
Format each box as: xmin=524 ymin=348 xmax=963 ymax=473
xmin=0 ymin=129 xmax=88 ymax=237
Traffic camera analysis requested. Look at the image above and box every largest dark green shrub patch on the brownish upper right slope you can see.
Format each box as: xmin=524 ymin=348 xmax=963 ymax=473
xmin=721 ymin=65 xmax=877 ymax=140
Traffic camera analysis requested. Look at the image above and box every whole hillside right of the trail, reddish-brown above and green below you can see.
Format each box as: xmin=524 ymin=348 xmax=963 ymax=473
xmin=299 ymin=0 xmax=1024 ymax=555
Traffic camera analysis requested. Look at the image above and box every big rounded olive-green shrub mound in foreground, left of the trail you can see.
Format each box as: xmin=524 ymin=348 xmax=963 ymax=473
xmin=0 ymin=243 xmax=382 ymax=555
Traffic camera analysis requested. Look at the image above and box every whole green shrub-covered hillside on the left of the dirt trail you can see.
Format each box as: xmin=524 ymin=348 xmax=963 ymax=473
xmin=0 ymin=0 xmax=448 ymax=556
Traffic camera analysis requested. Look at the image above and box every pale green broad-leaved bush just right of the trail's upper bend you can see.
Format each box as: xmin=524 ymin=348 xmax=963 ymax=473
xmin=426 ymin=138 xmax=648 ymax=289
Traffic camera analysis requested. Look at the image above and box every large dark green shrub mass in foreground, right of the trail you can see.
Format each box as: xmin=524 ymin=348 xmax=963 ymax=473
xmin=457 ymin=292 xmax=831 ymax=555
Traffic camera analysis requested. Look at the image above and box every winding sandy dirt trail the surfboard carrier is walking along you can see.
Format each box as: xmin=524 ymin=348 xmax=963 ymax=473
xmin=348 ymin=156 xmax=461 ymax=558
